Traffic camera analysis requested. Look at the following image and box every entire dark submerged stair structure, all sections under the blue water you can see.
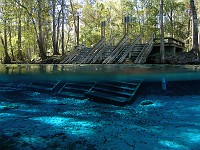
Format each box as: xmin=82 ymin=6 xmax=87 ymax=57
xmin=26 ymin=80 xmax=142 ymax=106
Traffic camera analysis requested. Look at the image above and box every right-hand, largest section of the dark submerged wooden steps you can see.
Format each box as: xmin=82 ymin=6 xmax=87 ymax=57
xmin=85 ymin=81 xmax=142 ymax=106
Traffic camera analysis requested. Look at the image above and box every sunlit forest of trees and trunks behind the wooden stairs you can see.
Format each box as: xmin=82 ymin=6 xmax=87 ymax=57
xmin=0 ymin=0 xmax=200 ymax=63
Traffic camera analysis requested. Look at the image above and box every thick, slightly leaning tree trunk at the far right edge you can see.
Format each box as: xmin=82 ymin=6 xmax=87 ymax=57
xmin=190 ymin=0 xmax=199 ymax=60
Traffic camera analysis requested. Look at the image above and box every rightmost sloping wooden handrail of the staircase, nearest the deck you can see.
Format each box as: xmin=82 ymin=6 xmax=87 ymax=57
xmin=134 ymin=35 xmax=154 ymax=64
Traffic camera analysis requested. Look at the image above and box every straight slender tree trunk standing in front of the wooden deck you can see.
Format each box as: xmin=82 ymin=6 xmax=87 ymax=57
xmin=160 ymin=0 xmax=165 ymax=63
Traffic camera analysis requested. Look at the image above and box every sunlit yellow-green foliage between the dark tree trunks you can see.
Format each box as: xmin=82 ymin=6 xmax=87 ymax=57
xmin=0 ymin=0 xmax=196 ymax=60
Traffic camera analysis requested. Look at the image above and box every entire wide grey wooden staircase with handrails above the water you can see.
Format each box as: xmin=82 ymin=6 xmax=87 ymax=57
xmin=60 ymin=34 xmax=154 ymax=64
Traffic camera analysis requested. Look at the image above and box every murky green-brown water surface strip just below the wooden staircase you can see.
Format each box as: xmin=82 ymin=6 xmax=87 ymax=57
xmin=0 ymin=64 xmax=200 ymax=80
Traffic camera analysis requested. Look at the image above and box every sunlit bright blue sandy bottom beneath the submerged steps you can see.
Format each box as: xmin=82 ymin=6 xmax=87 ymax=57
xmin=0 ymin=83 xmax=200 ymax=150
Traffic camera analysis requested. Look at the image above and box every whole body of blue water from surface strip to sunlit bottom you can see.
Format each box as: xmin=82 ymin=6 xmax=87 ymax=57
xmin=0 ymin=64 xmax=200 ymax=150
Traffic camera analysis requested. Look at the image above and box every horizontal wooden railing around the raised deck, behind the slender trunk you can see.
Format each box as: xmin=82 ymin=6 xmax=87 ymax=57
xmin=154 ymin=37 xmax=185 ymax=47
